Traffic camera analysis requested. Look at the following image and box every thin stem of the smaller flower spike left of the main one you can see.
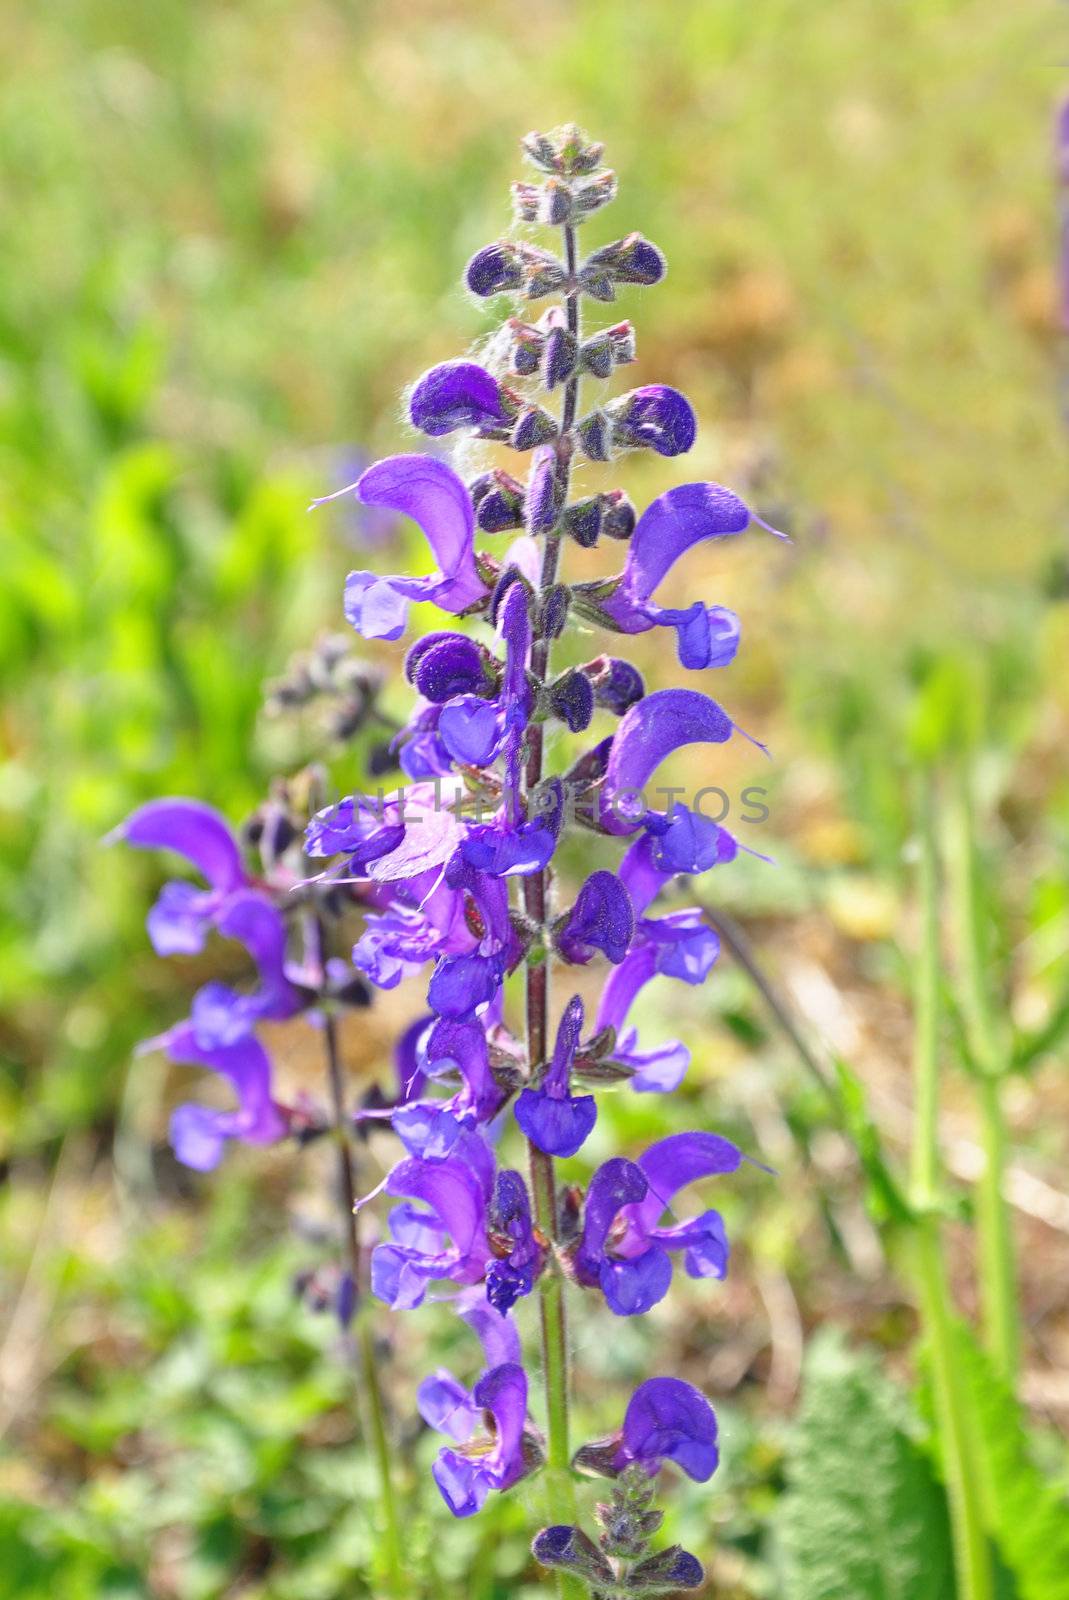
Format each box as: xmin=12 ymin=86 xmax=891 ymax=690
xmin=315 ymin=920 xmax=406 ymax=1600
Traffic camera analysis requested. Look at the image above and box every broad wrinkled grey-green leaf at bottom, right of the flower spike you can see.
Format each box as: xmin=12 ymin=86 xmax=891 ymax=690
xmin=776 ymin=1338 xmax=954 ymax=1600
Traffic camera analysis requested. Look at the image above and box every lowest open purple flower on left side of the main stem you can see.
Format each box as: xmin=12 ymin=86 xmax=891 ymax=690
xmin=432 ymin=1362 xmax=528 ymax=1517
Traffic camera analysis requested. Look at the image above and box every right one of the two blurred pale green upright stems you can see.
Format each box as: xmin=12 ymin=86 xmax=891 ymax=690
xmin=947 ymin=762 xmax=1019 ymax=1387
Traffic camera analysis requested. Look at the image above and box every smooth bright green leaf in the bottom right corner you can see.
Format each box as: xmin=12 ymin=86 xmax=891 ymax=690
xmin=954 ymin=1323 xmax=1069 ymax=1600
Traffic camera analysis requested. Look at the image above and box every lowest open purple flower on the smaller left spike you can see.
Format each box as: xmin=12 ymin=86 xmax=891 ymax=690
xmin=150 ymin=1022 xmax=286 ymax=1173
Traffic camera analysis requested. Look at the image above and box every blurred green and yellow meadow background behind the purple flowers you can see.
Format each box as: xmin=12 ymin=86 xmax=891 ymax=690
xmin=0 ymin=0 xmax=1069 ymax=1600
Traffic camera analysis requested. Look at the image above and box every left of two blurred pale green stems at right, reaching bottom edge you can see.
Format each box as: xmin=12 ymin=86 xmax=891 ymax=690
xmin=912 ymin=773 xmax=994 ymax=1600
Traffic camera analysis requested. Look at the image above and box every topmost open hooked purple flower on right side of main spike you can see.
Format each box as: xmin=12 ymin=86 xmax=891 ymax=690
xmin=591 ymin=483 xmax=771 ymax=669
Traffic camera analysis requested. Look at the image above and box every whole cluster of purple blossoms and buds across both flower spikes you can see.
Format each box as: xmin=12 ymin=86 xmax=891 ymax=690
xmin=120 ymin=128 xmax=775 ymax=1595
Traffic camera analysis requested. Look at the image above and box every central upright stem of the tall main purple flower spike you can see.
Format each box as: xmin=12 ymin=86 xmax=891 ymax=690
xmin=523 ymin=216 xmax=584 ymax=1600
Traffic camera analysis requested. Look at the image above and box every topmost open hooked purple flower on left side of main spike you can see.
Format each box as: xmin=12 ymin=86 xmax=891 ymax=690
xmin=312 ymin=456 xmax=488 ymax=638
